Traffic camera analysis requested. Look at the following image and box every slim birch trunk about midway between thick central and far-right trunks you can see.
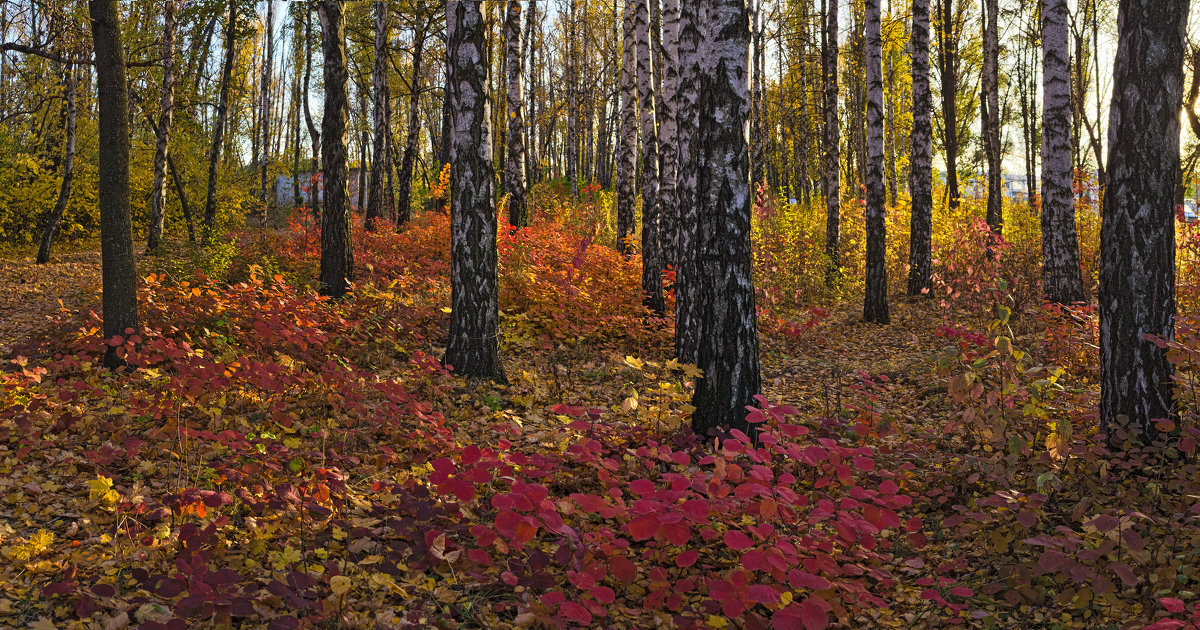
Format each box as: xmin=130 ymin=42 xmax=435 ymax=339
xmin=908 ymin=0 xmax=934 ymax=295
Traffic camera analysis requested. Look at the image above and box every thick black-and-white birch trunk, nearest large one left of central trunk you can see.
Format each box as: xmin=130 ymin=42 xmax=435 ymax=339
xmin=444 ymin=0 xmax=504 ymax=380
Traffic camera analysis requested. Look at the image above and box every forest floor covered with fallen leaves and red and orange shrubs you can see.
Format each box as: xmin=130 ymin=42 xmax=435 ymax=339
xmin=0 ymin=193 xmax=1200 ymax=630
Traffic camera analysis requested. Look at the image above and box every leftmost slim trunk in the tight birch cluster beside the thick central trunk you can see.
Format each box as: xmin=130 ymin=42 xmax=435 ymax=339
xmin=617 ymin=1 xmax=637 ymax=258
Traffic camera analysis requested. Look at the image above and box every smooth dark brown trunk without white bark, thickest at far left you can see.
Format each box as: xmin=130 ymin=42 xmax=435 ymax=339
xmin=88 ymin=0 xmax=138 ymax=368
